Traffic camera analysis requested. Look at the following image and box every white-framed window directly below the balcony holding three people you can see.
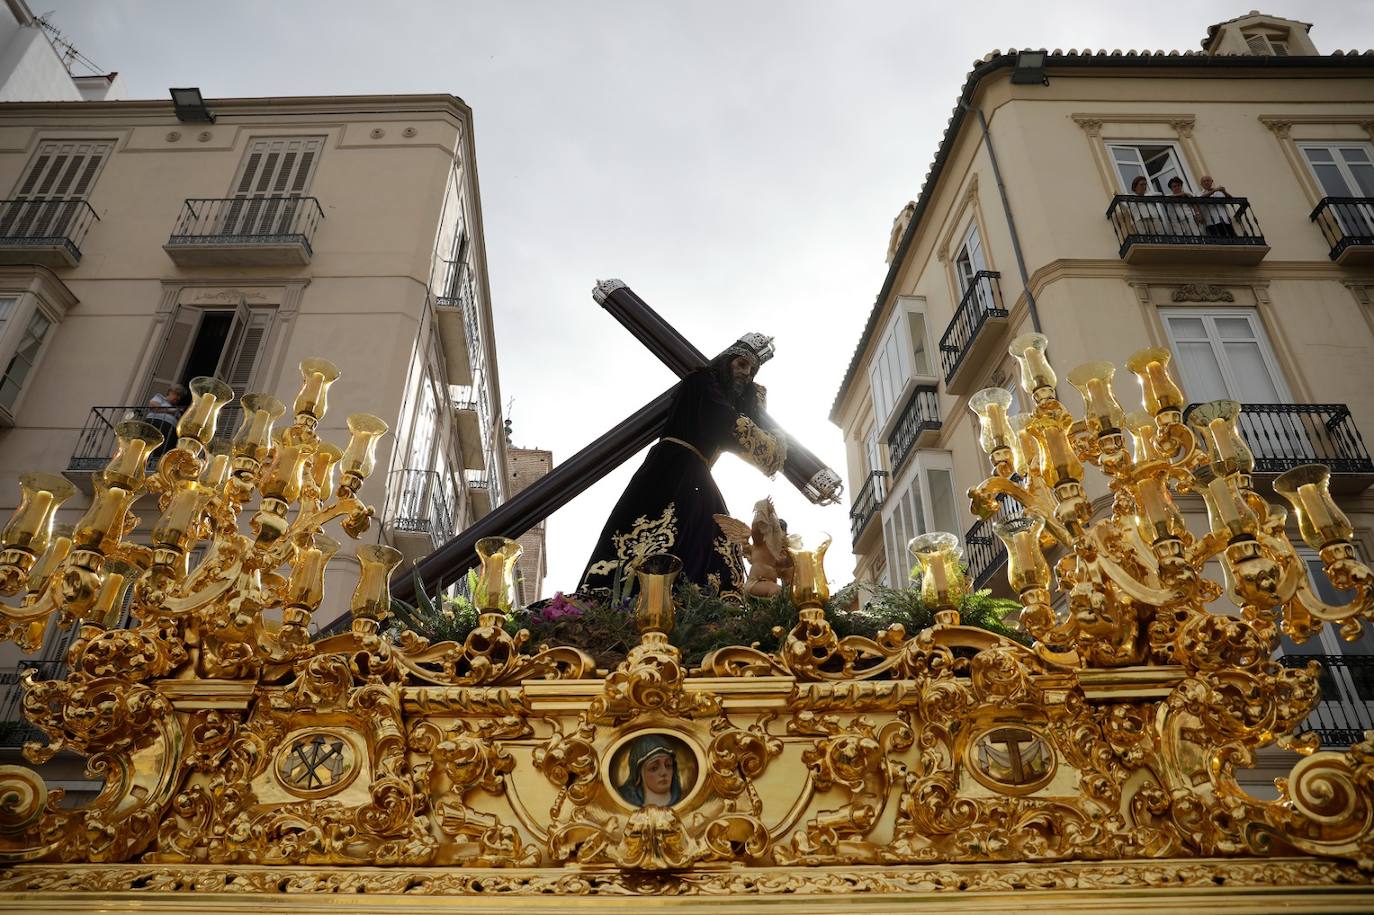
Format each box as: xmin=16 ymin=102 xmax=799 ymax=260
xmin=1160 ymin=308 xmax=1292 ymax=404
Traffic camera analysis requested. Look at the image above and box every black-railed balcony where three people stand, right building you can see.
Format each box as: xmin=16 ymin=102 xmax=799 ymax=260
xmin=1107 ymin=194 xmax=1270 ymax=267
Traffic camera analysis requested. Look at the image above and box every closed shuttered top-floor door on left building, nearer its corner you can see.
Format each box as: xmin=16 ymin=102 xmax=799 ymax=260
xmin=218 ymin=136 xmax=324 ymax=236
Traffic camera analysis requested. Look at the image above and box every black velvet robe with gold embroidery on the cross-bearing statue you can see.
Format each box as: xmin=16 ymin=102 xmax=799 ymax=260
xmin=581 ymin=368 xmax=787 ymax=595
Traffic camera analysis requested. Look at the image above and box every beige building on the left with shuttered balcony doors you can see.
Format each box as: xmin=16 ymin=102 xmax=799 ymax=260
xmin=0 ymin=95 xmax=508 ymax=747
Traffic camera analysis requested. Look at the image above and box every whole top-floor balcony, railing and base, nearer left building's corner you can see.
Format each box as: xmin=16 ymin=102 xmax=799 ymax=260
xmin=162 ymin=196 xmax=324 ymax=267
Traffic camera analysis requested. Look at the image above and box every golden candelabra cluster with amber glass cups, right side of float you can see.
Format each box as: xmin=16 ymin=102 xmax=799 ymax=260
xmin=969 ymin=334 xmax=1374 ymax=669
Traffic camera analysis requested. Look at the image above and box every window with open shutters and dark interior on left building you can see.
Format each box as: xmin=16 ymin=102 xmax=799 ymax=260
xmin=140 ymin=304 xmax=273 ymax=403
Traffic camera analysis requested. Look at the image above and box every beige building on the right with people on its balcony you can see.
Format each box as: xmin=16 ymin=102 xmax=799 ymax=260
xmin=831 ymin=14 xmax=1374 ymax=746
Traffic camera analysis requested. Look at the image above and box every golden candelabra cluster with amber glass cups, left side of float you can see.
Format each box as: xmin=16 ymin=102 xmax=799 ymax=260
xmin=0 ymin=359 xmax=400 ymax=677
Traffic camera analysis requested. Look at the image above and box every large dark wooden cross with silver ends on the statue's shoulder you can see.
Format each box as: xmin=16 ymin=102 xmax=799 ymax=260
xmin=392 ymin=280 xmax=842 ymax=600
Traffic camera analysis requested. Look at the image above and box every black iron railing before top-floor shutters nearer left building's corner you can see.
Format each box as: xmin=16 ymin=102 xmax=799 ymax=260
xmin=168 ymin=196 xmax=324 ymax=257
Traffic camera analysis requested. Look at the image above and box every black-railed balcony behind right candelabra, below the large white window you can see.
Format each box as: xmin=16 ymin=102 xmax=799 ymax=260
xmin=1189 ymin=404 xmax=1374 ymax=493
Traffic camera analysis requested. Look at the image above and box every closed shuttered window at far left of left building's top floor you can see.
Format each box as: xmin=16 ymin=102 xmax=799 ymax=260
xmin=0 ymin=140 xmax=114 ymax=238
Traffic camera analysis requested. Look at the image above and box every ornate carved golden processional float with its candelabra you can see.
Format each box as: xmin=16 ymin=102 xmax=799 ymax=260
xmin=0 ymin=335 xmax=1374 ymax=912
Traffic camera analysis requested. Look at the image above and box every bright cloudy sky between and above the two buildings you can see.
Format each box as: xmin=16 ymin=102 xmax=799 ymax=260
xmin=42 ymin=0 xmax=1374 ymax=594
